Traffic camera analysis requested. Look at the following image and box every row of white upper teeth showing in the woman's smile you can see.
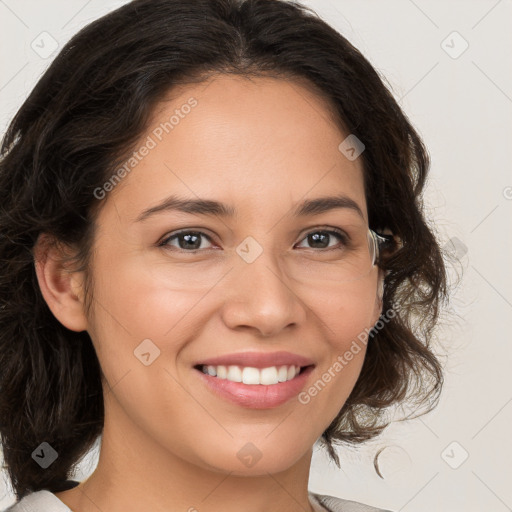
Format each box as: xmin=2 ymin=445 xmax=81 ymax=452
xmin=202 ymin=365 xmax=300 ymax=386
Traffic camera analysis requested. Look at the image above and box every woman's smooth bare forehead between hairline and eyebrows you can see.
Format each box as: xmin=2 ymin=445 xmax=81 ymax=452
xmin=102 ymin=75 xmax=366 ymax=224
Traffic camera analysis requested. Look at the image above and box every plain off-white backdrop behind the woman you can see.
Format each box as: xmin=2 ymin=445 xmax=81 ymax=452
xmin=0 ymin=0 xmax=512 ymax=512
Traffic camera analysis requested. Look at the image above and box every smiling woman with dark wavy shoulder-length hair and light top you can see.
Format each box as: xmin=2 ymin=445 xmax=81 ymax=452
xmin=0 ymin=0 xmax=446 ymax=512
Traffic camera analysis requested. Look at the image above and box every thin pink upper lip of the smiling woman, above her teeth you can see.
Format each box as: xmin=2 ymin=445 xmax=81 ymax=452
xmin=195 ymin=351 xmax=314 ymax=368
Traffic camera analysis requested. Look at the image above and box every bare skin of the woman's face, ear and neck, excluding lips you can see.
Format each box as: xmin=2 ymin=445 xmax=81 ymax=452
xmin=36 ymin=76 xmax=382 ymax=512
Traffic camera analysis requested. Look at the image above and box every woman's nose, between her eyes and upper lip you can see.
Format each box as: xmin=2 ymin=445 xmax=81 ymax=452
xmin=222 ymin=245 xmax=307 ymax=337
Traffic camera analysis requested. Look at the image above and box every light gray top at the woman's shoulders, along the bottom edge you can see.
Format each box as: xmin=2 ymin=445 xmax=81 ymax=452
xmin=3 ymin=490 xmax=390 ymax=512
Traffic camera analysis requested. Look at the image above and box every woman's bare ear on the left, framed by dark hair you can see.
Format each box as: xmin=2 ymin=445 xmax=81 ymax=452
xmin=33 ymin=233 xmax=87 ymax=332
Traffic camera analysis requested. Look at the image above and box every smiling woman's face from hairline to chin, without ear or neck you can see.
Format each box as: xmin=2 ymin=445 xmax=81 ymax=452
xmin=77 ymin=76 xmax=381 ymax=475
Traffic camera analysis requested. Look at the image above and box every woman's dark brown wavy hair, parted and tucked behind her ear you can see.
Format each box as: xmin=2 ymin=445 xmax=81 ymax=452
xmin=0 ymin=0 xmax=448 ymax=498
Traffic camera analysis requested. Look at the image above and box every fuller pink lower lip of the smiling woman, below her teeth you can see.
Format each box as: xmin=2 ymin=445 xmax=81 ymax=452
xmin=194 ymin=366 xmax=313 ymax=409
